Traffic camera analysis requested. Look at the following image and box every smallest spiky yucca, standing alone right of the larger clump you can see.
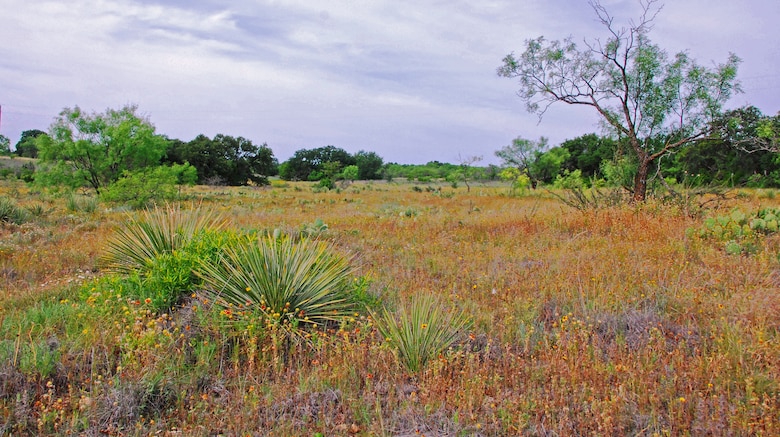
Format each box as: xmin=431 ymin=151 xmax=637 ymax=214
xmin=373 ymin=294 xmax=471 ymax=373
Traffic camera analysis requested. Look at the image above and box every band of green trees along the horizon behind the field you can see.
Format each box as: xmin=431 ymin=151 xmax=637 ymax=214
xmin=3 ymin=100 xmax=780 ymax=200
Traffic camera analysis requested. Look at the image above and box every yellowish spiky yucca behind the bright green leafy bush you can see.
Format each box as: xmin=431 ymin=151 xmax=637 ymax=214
xmin=101 ymin=205 xmax=226 ymax=273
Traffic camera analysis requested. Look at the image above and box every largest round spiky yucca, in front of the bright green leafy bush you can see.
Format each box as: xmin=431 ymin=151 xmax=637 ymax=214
xmin=201 ymin=233 xmax=354 ymax=328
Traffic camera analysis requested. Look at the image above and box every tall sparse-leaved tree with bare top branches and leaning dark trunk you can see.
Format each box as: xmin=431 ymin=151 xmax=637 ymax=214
xmin=498 ymin=0 xmax=740 ymax=201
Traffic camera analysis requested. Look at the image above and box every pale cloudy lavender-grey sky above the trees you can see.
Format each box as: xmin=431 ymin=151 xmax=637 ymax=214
xmin=0 ymin=0 xmax=780 ymax=164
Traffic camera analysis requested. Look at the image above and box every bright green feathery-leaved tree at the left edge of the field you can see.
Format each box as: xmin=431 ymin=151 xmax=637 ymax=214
xmin=35 ymin=105 xmax=166 ymax=194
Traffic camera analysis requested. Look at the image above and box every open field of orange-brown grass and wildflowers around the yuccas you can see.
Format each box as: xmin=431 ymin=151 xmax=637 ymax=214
xmin=0 ymin=182 xmax=780 ymax=436
